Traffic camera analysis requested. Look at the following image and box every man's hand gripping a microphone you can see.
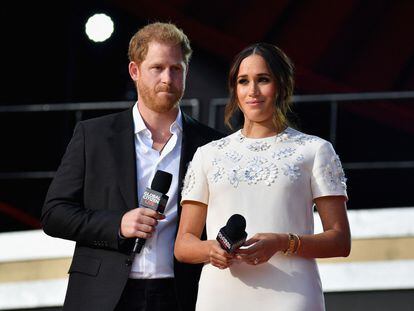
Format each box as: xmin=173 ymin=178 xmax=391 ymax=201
xmin=120 ymin=207 xmax=165 ymax=239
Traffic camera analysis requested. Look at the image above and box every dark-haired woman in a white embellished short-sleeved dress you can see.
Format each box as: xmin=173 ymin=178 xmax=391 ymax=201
xmin=175 ymin=43 xmax=350 ymax=311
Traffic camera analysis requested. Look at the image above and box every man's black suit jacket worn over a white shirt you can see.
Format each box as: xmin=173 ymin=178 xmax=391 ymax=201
xmin=42 ymin=109 xmax=221 ymax=311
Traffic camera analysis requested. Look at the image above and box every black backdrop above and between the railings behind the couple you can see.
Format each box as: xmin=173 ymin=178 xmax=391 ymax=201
xmin=0 ymin=0 xmax=414 ymax=231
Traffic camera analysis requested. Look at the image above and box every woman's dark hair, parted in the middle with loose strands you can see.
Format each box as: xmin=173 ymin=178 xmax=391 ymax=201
xmin=224 ymin=43 xmax=294 ymax=131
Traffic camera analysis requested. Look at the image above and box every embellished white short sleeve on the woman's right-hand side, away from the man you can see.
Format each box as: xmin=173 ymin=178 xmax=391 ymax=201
xmin=311 ymin=141 xmax=348 ymax=199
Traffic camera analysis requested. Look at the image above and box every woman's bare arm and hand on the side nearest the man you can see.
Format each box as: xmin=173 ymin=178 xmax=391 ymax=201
xmin=174 ymin=201 xmax=233 ymax=269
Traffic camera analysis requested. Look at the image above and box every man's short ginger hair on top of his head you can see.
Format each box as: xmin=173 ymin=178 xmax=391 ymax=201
xmin=128 ymin=22 xmax=193 ymax=65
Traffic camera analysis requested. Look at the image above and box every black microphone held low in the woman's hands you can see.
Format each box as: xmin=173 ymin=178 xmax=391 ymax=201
xmin=216 ymin=214 xmax=247 ymax=253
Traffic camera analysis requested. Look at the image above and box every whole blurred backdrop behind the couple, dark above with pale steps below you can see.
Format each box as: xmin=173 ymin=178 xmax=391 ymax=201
xmin=0 ymin=0 xmax=414 ymax=311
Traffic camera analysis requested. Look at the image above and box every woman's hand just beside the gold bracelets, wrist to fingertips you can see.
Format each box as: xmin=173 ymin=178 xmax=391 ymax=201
xmin=235 ymin=233 xmax=288 ymax=265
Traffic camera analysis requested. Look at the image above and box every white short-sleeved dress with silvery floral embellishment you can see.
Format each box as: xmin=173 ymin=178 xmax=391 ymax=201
xmin=182 ymin=128 xmax=347 ymax=311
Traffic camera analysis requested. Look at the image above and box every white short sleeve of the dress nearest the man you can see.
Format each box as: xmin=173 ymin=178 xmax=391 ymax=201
xmin=181 ymin=148 xmax=209 ymax=204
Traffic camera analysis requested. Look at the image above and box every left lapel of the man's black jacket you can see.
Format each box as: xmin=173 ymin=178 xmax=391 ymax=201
xmin=109 ymin=109 xmax=138 ymax=210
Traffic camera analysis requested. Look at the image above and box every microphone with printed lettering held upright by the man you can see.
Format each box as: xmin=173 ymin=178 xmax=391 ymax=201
xmin=132 ymin=170 xmax=172 ymax=254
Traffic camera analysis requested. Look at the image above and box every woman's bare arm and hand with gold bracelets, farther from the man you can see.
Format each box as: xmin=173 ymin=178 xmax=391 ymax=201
xmin=238 ymin=196 xmax=351 ymax=264
